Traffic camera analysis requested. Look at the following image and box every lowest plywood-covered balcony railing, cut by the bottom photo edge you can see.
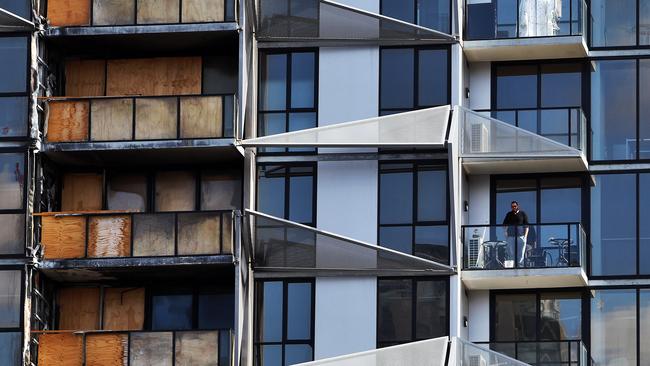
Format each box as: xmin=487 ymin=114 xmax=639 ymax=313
xmin=32 ymin=329 xmax=234 ymax=366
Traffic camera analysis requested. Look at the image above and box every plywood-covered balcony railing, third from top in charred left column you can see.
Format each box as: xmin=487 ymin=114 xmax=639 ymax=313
xmin=39 ymin=211 xmax=234 ymax=259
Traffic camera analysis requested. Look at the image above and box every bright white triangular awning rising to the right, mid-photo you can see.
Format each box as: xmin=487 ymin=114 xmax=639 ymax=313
xmin=241 ymin=105 xmax=451 ymax=148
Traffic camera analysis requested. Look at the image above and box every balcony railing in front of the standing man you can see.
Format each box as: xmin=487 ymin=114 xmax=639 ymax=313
xmin=462 ymin=223 xmax=586 ymax=270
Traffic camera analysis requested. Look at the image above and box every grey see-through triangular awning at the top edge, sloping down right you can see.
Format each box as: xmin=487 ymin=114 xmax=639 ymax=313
xmin=256 ymin=0 xmax=455 ymax=46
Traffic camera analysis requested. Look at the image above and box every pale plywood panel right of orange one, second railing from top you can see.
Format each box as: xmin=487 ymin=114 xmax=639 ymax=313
xmin=90 ymin=98 xmax=133 ymax=141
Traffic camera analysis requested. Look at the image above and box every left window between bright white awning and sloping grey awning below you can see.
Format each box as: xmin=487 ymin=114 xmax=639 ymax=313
xmin=257 ymin=164 xmax=316 ymax=226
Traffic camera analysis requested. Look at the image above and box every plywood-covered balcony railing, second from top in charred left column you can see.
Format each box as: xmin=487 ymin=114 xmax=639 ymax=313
xmin=46 ymin=94 xmax=235 ymax=143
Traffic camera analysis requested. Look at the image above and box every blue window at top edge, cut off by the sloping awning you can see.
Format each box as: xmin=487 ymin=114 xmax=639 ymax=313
xmin=381 ymin=0 xmax=451 ymax=34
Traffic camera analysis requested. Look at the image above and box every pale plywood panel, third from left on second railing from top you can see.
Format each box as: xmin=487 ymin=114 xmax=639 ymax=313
xmin=135 ymin=98 xmax=178 ymax=140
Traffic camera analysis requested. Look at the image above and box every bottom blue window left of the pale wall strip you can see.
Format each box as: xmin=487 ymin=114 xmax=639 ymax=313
xmin=255 ymin=280 xmax=314 ymax=366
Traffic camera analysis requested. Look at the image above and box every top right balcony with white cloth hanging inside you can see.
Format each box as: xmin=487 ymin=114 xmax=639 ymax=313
xmin=464 ymin=0 xmax=587 ymax=61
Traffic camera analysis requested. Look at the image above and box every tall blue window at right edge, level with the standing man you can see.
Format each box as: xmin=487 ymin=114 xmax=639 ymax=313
xmin=591 ymin=173 xmax=650 ymax=276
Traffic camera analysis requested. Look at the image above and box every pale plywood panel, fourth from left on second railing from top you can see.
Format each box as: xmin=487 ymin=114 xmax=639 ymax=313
xmin=181 ymin=96 xmax=223 ymax=138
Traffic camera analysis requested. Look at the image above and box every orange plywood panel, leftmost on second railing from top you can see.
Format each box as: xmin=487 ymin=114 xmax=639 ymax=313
xmin=46 ymin=100 xmax=90 ymax=142
